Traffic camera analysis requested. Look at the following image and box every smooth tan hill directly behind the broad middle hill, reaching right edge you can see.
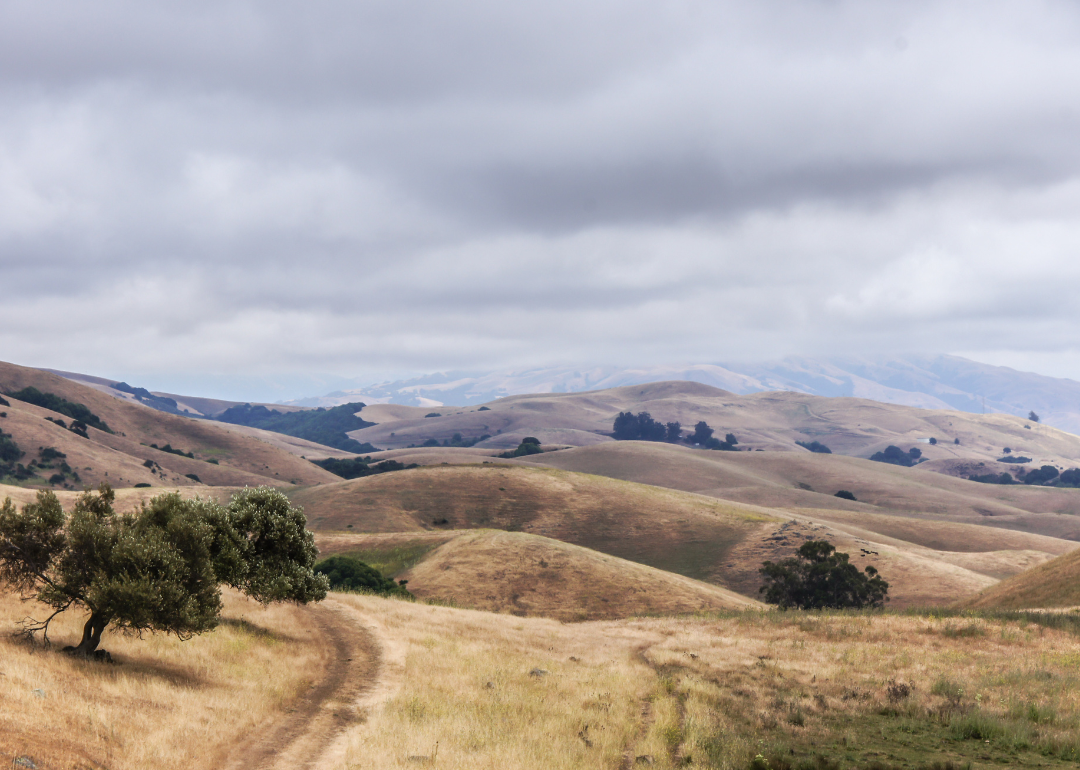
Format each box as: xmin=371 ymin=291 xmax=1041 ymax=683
xmin=531 ymin=442 xmax=1080 ymax=539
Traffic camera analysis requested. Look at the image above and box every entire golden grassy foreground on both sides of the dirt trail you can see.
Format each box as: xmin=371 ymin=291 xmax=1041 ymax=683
xmin=0 ymin=594 xmax=1080 ymax=770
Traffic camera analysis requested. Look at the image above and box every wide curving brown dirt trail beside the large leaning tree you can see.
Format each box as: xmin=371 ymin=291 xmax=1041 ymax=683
xmin=217 ymin=599 xmax=386 ymax=770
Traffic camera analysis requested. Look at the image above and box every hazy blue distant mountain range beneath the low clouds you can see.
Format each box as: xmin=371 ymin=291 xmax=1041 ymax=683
xmin=284 ymin=355 xmax=1080 ymax=434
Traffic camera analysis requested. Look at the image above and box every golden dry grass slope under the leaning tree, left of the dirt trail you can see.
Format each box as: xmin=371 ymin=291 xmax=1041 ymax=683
xmin=0 ymin=593 xmax=325 ymax=770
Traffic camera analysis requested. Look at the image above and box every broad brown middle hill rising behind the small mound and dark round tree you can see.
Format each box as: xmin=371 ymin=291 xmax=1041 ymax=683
xmin=291 ymin=465 xmax=1071 ymax=607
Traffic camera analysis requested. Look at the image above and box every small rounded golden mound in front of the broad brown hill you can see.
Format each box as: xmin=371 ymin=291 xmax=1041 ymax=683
xmin=319 ymin=529 xmax=762 ymax=621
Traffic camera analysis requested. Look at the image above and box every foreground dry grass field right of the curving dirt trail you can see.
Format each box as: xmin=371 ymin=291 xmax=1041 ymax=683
xmin=339 ymin=596 xmax=1080 ymax=770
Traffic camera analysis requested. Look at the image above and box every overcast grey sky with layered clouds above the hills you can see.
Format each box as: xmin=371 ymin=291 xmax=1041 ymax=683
xmin=0 ymin=0 xmax=1080 ymax=396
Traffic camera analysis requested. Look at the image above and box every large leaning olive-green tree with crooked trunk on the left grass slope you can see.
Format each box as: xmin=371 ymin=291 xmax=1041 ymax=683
xmin=0 ymin=484 xmax=328 ymax=656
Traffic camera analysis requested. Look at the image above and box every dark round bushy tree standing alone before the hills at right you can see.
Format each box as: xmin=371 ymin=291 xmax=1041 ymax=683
xmin=758 ymin=540 xmax=889 ymax=609
